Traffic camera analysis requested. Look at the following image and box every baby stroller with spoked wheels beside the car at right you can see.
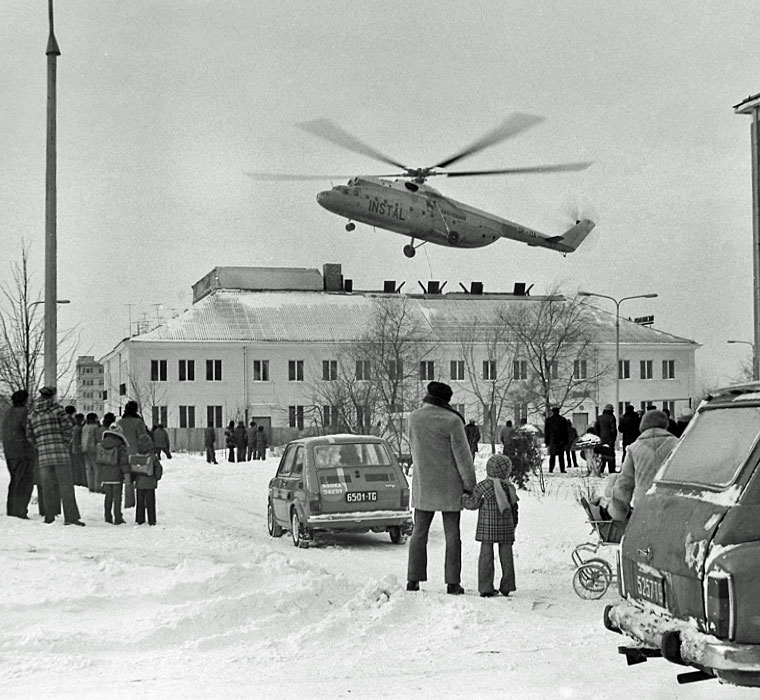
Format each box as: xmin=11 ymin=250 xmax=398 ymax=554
xmin=572 ymin=495 xmax=625 ymax=600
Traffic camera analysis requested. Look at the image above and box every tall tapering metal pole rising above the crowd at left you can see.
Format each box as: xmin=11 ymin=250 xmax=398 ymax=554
xmin=45 ymin=0 xmax=61 ymax=387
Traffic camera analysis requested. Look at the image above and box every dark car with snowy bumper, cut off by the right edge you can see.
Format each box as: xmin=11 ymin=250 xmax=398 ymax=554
xmin=604 ymin=382 xmax=760 ymax=686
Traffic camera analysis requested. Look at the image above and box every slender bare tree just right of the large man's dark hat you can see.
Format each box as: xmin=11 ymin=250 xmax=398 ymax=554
xmin=457 ymin=314 xmax=515 ymax=454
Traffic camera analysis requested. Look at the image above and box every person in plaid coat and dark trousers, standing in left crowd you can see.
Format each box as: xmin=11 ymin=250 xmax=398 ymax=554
xmin=26 ymin=386 xmax=84 ymax=526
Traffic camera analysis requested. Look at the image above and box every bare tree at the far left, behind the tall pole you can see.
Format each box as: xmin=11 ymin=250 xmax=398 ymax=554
xmin=0 ymin=243 xmax=79 ymax=395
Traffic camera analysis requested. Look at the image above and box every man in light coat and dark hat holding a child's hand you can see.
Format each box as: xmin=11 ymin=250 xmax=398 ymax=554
xmin=406 ymin=382 xmax=475 ymax=595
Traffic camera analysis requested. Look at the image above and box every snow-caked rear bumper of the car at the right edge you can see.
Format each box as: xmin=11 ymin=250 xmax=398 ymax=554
xmin=605 ymin=600 xmax=760 ymax=673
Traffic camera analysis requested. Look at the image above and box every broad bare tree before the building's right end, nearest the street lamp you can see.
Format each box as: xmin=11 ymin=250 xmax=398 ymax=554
xmin=500 ymin=289 xmax=604 ymax=417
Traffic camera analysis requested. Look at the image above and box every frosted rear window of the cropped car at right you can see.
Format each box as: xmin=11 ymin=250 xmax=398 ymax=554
xmin=658 ymin=406 xmax=760 ymax=488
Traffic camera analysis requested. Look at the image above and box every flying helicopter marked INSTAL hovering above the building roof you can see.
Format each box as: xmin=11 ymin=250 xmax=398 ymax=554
xmin=248 ymin=113 xmax=595 ymax=258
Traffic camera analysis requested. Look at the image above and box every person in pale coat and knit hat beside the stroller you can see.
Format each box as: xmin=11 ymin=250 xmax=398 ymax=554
xmin=607 ymin=410 xmax=678 ymax=520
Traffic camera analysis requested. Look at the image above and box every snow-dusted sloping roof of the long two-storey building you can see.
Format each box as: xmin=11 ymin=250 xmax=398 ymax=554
xmin=130 ymin=289 xmax=697 ymax=345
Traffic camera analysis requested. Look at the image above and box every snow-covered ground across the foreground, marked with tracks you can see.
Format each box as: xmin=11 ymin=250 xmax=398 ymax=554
xmin=0 ymin=447 xmax=757 ymax=700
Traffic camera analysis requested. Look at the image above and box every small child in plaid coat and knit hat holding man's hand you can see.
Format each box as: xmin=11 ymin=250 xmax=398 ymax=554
xmin=462 ymin=454 xmax=518 ymax=598
